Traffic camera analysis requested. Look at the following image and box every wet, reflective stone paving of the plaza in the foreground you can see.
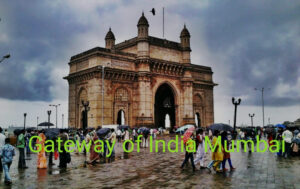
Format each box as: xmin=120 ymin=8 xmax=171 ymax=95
xmin=0 ymin=136 xmax=300 ymax=189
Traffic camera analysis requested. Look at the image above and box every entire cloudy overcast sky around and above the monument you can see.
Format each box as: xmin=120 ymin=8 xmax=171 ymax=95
xmin=0 ymin=0 xmax=300 ymax=126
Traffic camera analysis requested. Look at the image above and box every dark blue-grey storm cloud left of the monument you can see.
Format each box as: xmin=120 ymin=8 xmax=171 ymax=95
xmin=0 ymin=1 xmax=85 ymax=101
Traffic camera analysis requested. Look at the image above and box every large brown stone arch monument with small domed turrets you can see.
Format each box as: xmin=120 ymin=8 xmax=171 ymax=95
xmin=65 ymin=13 xmax=216 ymax=128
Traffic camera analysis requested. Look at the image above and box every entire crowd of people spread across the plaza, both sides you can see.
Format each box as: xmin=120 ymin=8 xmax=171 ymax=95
xmin=0 ymin=127 xmax=300 ymax=184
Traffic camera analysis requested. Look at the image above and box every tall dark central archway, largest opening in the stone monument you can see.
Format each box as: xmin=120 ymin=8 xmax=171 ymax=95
xmin=154 ymin=83 xmax=175 ymax=129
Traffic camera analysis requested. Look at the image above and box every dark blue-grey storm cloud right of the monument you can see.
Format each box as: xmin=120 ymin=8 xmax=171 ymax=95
xmin=171 ymin=0 xmax=300 ymax=106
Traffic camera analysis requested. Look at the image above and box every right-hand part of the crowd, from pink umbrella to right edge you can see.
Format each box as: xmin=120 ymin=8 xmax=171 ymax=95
xmin=181 ymin=127 xmax=300 ymax=173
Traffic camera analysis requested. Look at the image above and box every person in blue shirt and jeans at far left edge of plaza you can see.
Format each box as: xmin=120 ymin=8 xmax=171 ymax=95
xmin=0 ymin=138 xmax=15 ymax=185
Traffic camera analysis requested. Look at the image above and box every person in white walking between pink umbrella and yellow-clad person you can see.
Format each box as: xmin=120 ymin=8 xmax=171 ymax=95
xmin=194 ymin=128 xmax=205 ymax=169
